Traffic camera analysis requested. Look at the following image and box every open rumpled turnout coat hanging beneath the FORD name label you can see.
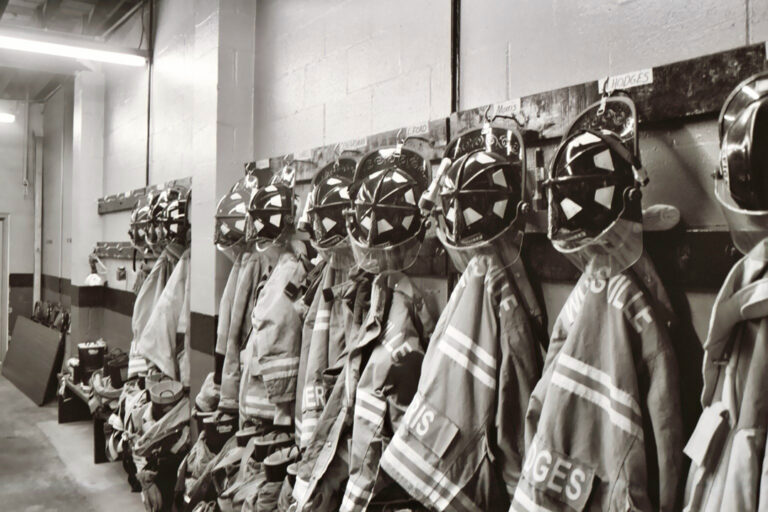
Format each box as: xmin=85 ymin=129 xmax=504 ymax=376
xmin=293 ymin=273 xmax=434 ymax=512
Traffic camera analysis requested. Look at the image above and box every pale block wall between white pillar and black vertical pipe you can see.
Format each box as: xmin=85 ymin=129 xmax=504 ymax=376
xmin=254 ymin=0 xmax=450 ymax=158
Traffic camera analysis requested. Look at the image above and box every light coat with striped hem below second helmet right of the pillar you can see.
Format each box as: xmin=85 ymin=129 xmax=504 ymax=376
xmin=252 ymin=258 xmax=306 ymax=404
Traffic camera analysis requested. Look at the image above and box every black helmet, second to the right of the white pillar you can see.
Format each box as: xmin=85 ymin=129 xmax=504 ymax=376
xmin=247 ymin=177 xmax=296 ymax=242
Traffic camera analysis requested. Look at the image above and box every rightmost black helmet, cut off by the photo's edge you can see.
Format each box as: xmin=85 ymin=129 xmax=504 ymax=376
xmin=718 ymin=72 xmax=768 ymax=210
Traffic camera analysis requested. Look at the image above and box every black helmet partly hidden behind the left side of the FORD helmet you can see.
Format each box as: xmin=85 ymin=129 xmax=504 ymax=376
xmin=307 ymin=158 xmax=357 ymax=250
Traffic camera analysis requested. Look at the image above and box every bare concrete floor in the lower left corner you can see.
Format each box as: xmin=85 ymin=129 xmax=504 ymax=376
xmin=0 ymin=377 xmax=144 ymax=512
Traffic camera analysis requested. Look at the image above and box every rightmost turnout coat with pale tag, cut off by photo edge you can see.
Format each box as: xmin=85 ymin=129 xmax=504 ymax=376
xmin=685 ymin=240 xmax=768 ymax=512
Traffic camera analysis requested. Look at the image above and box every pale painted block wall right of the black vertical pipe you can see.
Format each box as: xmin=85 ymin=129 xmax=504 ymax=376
xmin=461 ymin=0 xmax=768 ymax=108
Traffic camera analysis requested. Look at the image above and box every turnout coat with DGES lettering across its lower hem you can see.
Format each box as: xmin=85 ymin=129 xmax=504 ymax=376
xmin=510 ymin=256 xmax=682 ymax=512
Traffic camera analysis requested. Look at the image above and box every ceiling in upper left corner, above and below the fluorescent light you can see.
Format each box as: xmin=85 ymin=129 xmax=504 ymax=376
xmin=0 ymin=0 xmax=144 ymax=101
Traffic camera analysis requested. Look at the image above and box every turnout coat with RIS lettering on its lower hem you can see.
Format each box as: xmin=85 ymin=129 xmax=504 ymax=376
xmin=381 ymin=256 xmax=543 ymax=511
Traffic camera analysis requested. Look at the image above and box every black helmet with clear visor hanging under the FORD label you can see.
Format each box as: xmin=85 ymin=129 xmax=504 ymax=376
xmin=347 ymin=146 xmax=429 ymax=272
